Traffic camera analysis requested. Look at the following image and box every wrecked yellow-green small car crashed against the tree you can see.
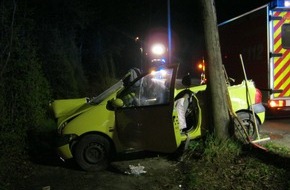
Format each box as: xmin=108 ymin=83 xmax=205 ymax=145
xmin=51 ymin=65 xmax=265 ymax=171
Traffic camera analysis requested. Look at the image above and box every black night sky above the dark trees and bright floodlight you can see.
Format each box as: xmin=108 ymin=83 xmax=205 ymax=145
xmin=28 ymin=0 xmax=269 ymax=77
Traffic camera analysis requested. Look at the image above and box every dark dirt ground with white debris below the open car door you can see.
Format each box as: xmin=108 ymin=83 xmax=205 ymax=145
xmin=19 ymin=152 xmax=185 ymax=190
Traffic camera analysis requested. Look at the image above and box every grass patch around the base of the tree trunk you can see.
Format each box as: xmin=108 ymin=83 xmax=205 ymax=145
xmin=183 ymin=137 xmax=290 ymax=190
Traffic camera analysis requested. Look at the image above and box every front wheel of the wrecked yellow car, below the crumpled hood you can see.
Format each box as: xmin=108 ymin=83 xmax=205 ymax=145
xmin=74 ymin=134 xmax=110 ymax=171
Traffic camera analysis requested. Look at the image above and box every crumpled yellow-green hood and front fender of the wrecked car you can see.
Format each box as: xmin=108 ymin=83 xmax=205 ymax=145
xmin=52 ymin=94 xmax=124 ymax=154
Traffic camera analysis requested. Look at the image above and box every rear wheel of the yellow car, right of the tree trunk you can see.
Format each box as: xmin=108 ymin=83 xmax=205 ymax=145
xmin=234 ymin=112 xmax=260 ymax=141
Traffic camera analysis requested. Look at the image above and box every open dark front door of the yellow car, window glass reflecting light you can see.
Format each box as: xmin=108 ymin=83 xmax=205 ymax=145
xmin=115 ymin=66 xmax=180 ymax=152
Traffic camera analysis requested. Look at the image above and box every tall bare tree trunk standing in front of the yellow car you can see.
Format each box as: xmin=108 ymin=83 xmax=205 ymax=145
xmin=200 ymin=0 xmax=230 ymax=140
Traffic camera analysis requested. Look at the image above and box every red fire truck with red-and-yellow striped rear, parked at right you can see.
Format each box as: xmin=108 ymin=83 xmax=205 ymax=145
xmin=218 ymin=0 xmax=290 ymax=116
